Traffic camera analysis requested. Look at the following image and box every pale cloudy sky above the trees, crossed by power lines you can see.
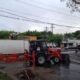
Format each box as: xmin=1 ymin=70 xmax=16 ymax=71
xmin=0 ymin=0 xmax=80 ymax=33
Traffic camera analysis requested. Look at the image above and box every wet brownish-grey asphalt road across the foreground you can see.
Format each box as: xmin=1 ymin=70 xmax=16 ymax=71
xmin=0 ymin=62 xmax=80 ymax=80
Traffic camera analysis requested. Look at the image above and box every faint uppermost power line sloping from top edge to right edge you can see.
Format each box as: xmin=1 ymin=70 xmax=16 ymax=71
xmin=15 ymin=0 xmax=80 ymax=19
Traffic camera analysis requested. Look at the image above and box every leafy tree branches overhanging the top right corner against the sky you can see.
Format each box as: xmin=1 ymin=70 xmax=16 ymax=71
xmin=61 ymin=0 xmax=80 ymax=12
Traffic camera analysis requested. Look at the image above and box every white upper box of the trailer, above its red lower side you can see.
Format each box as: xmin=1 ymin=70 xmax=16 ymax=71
xmin=0 ymin=40 xmax=30 ymax=54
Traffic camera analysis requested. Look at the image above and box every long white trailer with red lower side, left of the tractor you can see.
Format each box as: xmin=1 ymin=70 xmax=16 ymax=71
xmin=0 ymin=40 xmax=30 ymax=62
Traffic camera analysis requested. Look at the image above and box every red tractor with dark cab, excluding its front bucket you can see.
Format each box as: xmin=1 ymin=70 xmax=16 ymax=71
xmin=30 ymin=40 xmax=62 ymax=65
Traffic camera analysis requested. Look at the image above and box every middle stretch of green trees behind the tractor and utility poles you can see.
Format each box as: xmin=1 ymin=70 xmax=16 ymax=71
xmin=20 ymin=31 xmax=63 ymax=42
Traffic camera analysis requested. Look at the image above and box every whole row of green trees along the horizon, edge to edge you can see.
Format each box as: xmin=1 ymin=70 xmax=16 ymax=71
xmin=0 ymin=30 xmax=80 ymax=43
